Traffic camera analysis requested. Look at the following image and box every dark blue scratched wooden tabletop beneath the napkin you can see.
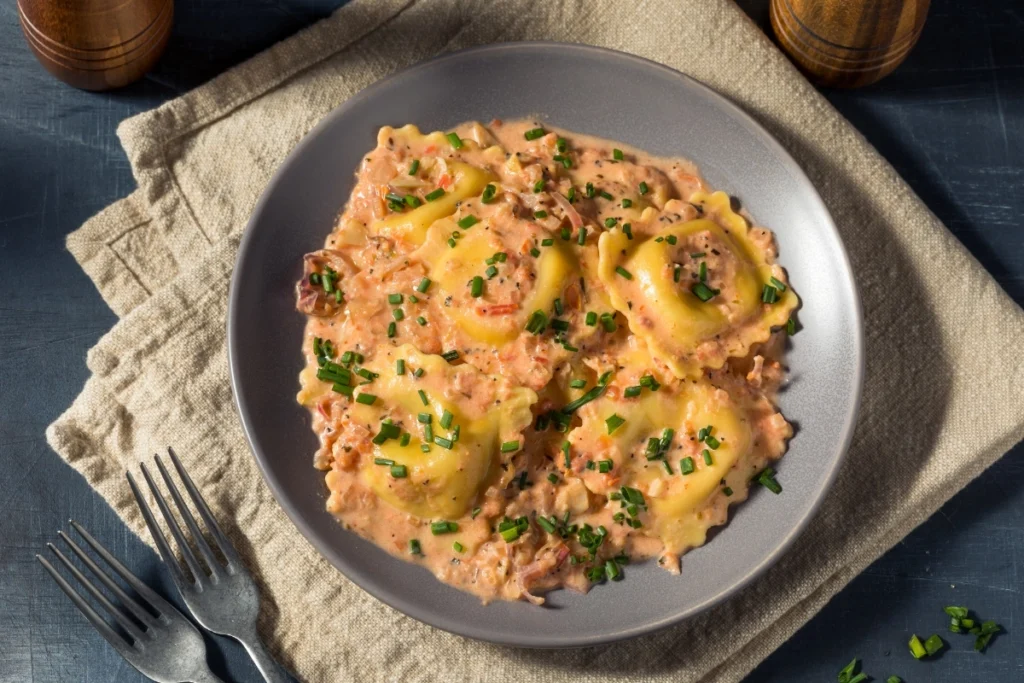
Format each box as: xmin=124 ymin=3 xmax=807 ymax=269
xmin=0 ymin=0 xmax=1024 ymax=683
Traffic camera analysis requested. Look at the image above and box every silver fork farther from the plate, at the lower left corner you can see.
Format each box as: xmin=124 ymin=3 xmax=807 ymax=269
xmin=36 ymin=519 xmax=222 ymax=683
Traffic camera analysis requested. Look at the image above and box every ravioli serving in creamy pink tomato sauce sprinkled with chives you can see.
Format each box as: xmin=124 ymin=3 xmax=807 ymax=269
xmin=297 ymin=121 xmax=798 ymax=603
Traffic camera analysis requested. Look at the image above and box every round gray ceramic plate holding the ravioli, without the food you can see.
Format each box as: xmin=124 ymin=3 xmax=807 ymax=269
xmin=228 ymin=43 xmax=862 ymax=647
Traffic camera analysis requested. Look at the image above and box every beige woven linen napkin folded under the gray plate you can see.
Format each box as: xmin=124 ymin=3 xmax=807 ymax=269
xmin=47 ymin=0 xmax=1024 ymax=683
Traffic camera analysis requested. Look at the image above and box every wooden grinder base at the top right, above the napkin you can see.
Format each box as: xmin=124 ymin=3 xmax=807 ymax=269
xmin=769 ymin=0 xmax=930 ymax=88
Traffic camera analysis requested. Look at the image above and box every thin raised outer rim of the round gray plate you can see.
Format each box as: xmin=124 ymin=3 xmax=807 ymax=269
xmin=226 ymin=40 xmax=865 ymax=649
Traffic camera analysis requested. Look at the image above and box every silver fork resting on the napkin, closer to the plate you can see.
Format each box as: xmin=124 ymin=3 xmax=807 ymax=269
xmin=126 ymin=449 xmax=289 ymax=683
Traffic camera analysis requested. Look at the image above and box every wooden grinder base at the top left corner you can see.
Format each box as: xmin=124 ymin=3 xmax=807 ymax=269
xmin=17 ymin=0 xmax=174 ymax=90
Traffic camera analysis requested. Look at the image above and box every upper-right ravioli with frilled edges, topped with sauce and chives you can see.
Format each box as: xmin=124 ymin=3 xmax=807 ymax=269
xmin=598 ymin=193 xmax=798 ymax=378
